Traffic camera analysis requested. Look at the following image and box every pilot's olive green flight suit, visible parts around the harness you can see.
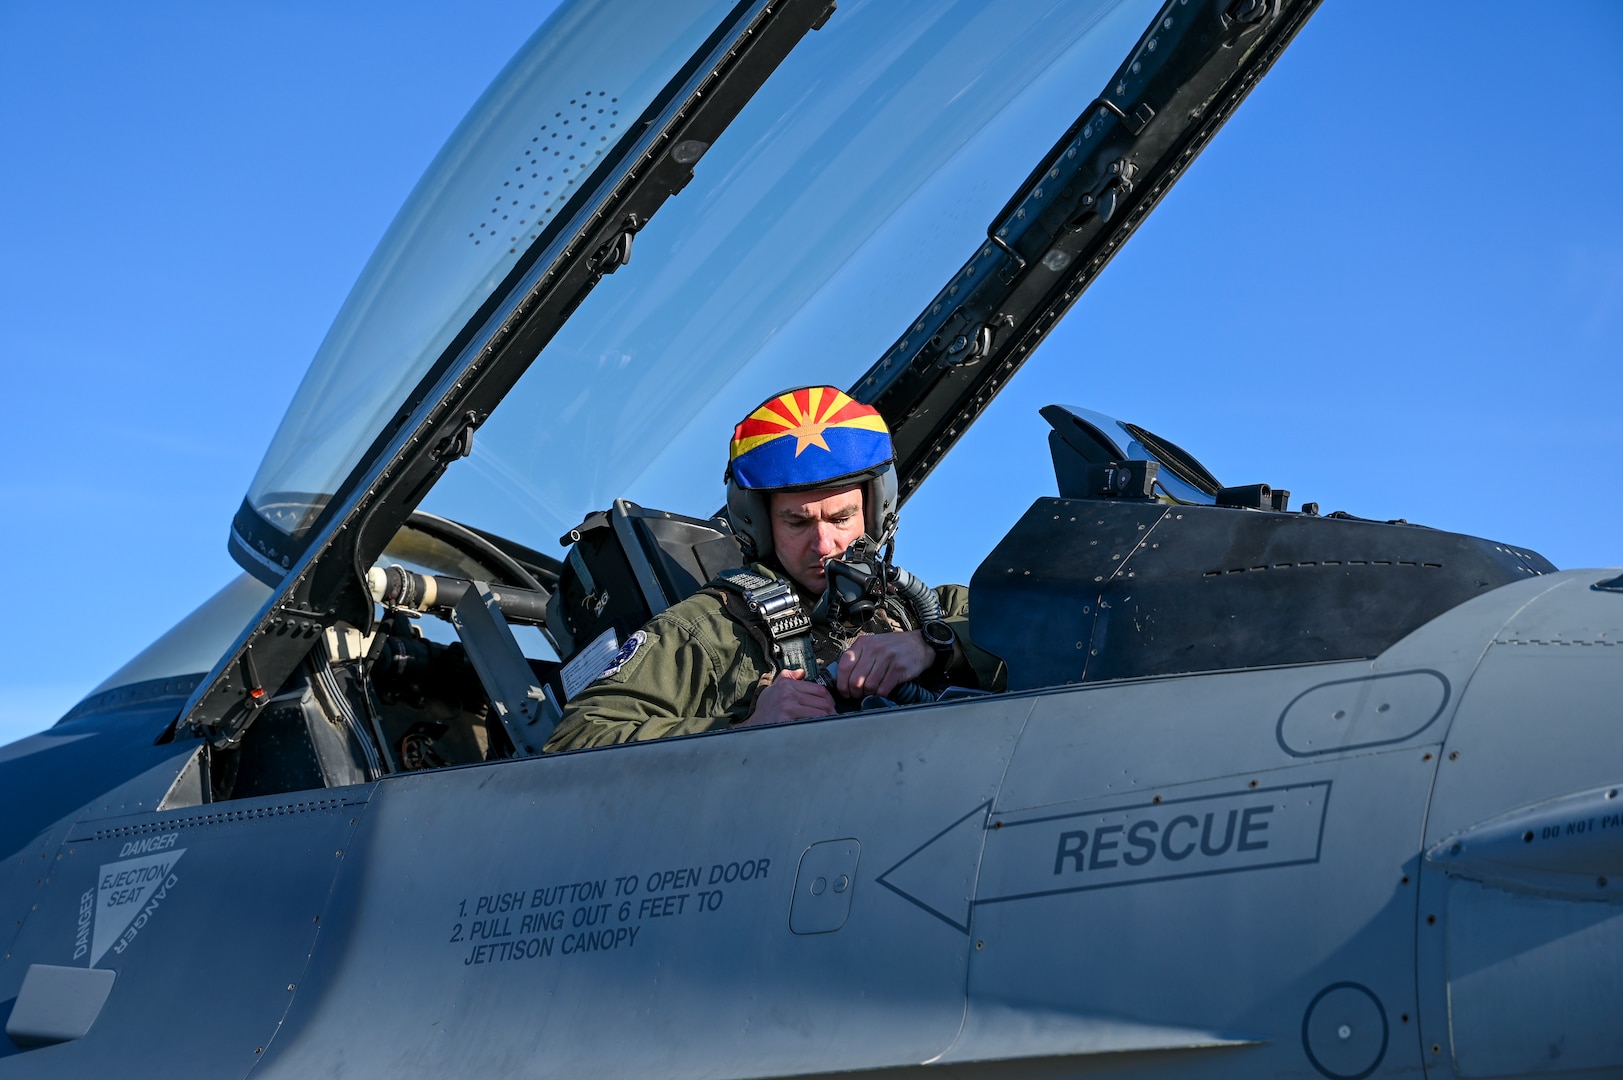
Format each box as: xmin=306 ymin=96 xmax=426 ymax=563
xmin=544 ymin=564 xmax=1005 ymax=752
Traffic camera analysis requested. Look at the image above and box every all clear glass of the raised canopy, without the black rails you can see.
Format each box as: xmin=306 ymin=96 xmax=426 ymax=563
xmin=248 ymin=0 xmax=1160 ymax=565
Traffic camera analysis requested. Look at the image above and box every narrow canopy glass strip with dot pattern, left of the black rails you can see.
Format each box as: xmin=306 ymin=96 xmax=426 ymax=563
xmin=248 ymin=0 xmax=735 ymax=536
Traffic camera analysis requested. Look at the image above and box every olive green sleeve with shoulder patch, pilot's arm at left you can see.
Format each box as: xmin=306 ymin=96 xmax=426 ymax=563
xmin=544 ymin=612 xmax=761 ymax=754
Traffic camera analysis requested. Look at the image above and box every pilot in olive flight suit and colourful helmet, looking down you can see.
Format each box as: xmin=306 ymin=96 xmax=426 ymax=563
xmin=545 ymin=387 xmax=1005 ymax=750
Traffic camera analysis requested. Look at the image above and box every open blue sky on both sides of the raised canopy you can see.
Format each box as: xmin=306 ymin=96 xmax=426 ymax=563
xmin=0 ymin=0 xmax=1623 ymax=742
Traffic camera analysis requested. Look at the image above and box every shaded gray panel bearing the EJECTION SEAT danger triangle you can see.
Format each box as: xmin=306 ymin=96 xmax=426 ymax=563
xmin=0 ymin=779 xmax=370 ymax=1080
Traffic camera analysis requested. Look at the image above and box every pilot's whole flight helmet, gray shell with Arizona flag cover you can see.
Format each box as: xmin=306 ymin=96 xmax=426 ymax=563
xmin=725 ymin=387 xmax=896 ymax=559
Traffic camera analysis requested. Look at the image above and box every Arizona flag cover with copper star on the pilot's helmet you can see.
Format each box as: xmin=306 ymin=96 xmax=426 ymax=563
xmin=729 ymin=387 xmax=896 ymax=490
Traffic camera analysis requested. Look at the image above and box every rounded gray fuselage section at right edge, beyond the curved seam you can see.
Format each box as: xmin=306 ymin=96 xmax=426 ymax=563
xmin=1419 ymin=570 xmax=1623 ymax=1078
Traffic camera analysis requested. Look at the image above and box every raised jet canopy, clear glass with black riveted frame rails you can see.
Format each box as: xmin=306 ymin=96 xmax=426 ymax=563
xmin=202 ymin=0 xmax=1316 ymax=724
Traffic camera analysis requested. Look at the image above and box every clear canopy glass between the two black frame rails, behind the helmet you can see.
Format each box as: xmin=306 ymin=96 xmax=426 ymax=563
xmin=424 ymin=0 xmax=1160 ymax=551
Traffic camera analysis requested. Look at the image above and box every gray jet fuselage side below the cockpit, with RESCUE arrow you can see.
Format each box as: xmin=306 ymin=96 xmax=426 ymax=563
xmin=0 ymin=558 xmax=1623 ymax=1077
